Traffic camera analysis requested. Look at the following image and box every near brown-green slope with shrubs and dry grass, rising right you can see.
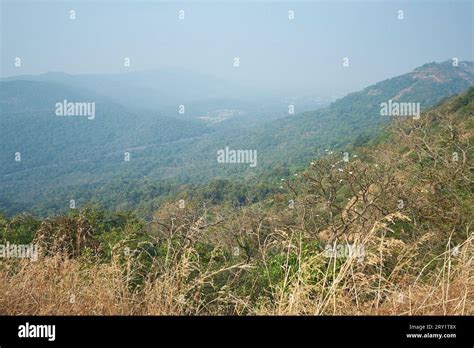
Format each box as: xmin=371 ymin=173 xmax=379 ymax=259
xmin=0 ymin=88 xmax=474 ymax=315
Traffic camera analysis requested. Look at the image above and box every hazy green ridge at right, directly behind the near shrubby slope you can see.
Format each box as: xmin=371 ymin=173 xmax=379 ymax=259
xmin=242 ymin=61 xmax=474 ymax=166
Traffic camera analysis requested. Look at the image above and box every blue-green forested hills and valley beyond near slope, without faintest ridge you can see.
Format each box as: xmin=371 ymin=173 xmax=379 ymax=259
xmin=0 ymin=61 xmax=474 ymax=216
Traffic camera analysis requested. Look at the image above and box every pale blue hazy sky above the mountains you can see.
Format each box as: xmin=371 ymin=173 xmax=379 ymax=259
xmin=0 ymin=0 xmax=474 ymax=93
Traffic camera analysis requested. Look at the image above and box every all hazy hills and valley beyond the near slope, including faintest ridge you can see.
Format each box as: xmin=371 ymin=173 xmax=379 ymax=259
xmin=0 ymin=61 xmax=474 ymax=215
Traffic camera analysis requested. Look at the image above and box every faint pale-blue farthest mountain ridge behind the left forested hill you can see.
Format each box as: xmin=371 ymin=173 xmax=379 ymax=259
xmin=3 ymin=68 xmax=254 ymax=109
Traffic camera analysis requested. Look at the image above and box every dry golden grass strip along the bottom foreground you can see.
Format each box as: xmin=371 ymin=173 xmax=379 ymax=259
xmin=0 ymin=228 xmax=474 ymax=315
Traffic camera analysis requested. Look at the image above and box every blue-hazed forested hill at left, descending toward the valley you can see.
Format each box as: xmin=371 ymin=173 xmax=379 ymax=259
xmin=0 ymin=80 xmax=212 ymax=213
